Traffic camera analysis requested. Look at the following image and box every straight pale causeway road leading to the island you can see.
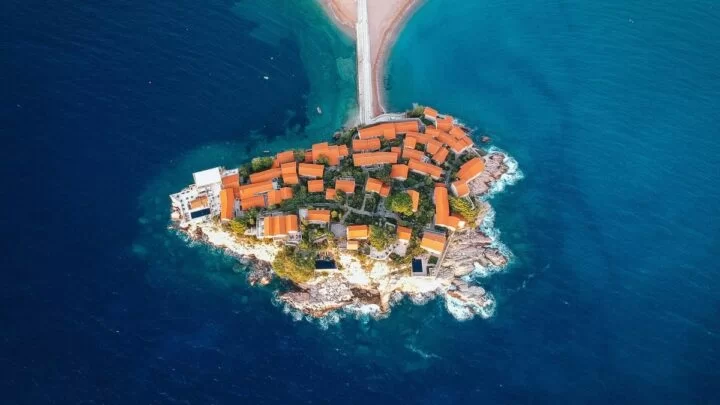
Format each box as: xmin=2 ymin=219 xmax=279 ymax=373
xmin=356 ymin=0 xmax=373 ymax=124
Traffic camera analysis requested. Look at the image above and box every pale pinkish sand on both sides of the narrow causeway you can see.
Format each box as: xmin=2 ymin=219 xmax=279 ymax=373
xmin=320 ymin=0 xmax=422 ymax=115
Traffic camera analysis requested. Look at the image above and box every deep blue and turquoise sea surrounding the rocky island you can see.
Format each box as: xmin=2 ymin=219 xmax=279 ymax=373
xmin=0 ymin=0 xmax=720 ymax=404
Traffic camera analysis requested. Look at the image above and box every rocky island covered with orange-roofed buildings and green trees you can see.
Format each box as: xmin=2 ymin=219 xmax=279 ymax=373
xmin=170 ymin=106 xmax=516 ymax=319
